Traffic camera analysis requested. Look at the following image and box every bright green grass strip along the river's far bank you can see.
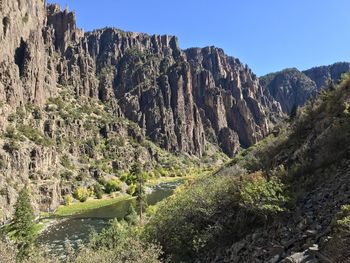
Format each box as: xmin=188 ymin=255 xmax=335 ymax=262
xmin=53 ymin=195 xmax=134 ymax=217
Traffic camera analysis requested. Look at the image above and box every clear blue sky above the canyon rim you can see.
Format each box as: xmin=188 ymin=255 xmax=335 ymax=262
xmin=48 ymin=0 xmax=350 ymax=76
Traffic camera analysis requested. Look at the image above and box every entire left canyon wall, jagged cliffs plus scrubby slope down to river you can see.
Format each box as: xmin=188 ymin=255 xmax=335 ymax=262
xmin=0 ymin=0 xmax=281 ymax=218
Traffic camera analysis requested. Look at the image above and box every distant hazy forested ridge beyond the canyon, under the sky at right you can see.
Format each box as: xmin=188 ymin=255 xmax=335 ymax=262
xmin=260 ymin=62 xmax=350 ymax=114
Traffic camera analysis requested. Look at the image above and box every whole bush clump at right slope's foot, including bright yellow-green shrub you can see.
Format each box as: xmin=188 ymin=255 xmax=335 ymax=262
xmin=145 ymin=173 xmax=286 ymax=262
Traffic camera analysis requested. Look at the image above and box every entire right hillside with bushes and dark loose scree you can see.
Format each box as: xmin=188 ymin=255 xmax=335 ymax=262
xmin=146 ymin=75 xmax=350 ymax=263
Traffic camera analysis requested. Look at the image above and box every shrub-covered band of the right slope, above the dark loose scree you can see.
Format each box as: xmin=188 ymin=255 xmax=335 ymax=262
xmin=146 ymin=75 xmax=350 ymax=262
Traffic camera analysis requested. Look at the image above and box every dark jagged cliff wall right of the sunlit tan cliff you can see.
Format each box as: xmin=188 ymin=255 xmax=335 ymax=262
xmin=43 ymin=6 xmax=280 ymax=156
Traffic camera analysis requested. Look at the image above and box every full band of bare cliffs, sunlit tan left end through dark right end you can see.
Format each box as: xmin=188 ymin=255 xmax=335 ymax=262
xmin=1 ymin=0 xmax=279 ymax=156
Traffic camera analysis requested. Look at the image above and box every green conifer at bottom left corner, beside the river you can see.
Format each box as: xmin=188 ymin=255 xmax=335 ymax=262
xmin=10 ymin=188 xmax=35 ymax=261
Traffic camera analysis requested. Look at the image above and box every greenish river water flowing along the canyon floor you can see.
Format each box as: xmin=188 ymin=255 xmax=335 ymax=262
xmin=38 ymin=179 xmax=183 ymax=255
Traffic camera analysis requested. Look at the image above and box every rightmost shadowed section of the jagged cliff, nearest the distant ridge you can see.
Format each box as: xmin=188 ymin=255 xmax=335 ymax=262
xmin=185 ymin=47 xmax=280 ymax=148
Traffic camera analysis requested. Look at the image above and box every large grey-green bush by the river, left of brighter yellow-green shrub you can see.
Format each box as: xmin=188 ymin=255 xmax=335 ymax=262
xmin=145 ymin=176 xmax=243 ymax=262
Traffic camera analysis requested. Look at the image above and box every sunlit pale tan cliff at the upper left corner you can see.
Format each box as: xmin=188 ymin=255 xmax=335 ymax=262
xmin=0 ymin=0 xmax=56 ymax=106
